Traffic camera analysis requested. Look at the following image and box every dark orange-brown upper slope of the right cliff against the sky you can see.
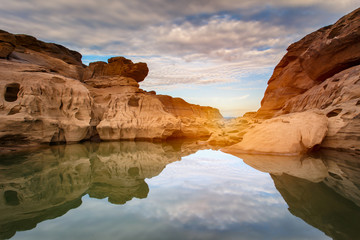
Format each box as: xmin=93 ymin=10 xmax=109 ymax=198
xmin=257 ymin=8 xmax=360 ymax=118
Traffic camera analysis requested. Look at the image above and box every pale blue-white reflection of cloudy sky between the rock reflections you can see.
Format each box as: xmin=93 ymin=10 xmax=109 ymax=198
xmin=11 ymin=150 xmax=324 ymax=240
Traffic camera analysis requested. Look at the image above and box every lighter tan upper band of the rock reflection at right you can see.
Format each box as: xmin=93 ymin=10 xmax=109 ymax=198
xmin=233 ymin=150 xmax=360 ymax=206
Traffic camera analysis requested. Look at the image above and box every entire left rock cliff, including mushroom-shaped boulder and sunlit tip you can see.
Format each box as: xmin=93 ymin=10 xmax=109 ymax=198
xmin=0 ymin=31 xmax=222 ymax=146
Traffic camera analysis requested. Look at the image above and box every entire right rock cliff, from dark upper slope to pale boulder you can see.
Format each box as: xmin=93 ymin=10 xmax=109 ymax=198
xmin=222 ymin=8 xmax=360 ymax=155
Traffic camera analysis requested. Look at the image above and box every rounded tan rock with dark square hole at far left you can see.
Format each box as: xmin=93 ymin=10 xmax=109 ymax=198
xmin=0 ymin=60 xmax=92 ymax=144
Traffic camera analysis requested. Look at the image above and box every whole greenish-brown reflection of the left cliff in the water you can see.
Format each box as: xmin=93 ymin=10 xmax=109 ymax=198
xmin=0 ymin=142 xmax=202 ymax=239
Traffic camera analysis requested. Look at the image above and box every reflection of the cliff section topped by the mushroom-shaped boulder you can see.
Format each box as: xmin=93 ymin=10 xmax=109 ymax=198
xmin=88 ymin=142 xmax=181 ymax=204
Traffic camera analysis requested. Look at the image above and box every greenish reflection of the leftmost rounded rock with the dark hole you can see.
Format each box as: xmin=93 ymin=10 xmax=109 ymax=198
xmin=0 ymin=145 xmax=91 ymax=238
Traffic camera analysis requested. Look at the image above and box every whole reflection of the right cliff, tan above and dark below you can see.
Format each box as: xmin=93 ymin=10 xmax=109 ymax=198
xmin=235 ymin=150 xmax=360 ymax=240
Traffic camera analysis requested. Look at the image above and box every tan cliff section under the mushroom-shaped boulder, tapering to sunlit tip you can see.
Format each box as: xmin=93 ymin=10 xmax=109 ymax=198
xmin=84 ymin=58 xmax=222 ymax=140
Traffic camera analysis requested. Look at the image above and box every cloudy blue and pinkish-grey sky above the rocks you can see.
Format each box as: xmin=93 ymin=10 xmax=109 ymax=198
xmin=0 ymin=0 xmax=360 ymax=117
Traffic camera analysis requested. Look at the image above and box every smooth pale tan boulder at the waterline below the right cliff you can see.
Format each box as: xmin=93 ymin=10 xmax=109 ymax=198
xmin=222 ymin=111 xmax=328 ymax=155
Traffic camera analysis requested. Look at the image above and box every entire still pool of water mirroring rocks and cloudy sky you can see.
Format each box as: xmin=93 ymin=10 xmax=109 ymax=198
xmin=0 ymin=142 xmax=360 ymax=240
